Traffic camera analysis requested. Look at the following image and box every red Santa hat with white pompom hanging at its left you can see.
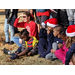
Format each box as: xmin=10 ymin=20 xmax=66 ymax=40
xmin=41 ymin=18 xmax=58 ymax=28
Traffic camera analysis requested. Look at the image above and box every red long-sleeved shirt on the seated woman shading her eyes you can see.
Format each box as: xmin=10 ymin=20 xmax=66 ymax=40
xmin=14 ymin=18 xmax=39 ymax=39
